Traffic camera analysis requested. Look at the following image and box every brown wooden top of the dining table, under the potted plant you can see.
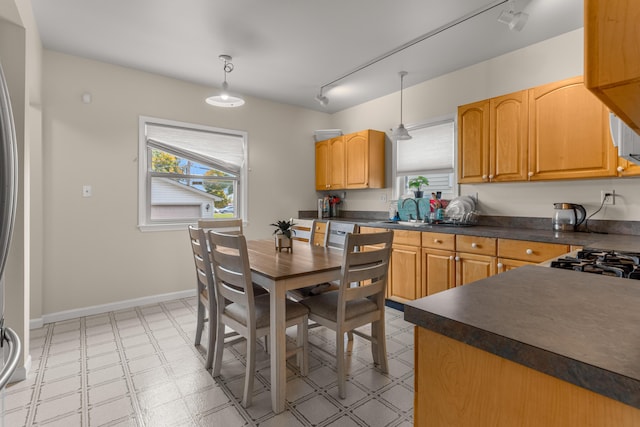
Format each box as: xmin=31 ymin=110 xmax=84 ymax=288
xmin=247 ymin=239 xmax=343 ymax=280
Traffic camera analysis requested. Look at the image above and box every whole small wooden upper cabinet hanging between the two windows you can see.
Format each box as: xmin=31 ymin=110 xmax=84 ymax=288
xmin=316 ymin=129 xmax=385 ymax=191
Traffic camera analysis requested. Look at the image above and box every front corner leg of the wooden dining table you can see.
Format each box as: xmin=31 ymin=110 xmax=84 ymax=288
xmin=270 ymin=286 xmax=287 ymax=414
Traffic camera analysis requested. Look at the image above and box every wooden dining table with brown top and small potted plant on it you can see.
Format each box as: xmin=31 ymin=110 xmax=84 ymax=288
xmin=247 ymin=240 xmax=343 ymax=413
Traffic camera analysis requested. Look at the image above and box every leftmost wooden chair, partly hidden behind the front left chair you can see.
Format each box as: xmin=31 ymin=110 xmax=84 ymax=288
xmin=189 ymin=225 xmax=217 ymax=369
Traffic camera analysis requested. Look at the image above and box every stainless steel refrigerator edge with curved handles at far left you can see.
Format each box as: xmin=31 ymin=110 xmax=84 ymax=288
xmin=0 ymin=59 xmax=20 ymax=412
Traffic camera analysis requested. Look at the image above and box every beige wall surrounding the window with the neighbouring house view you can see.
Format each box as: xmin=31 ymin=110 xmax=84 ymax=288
xmin=42 ymin=51 xmax=330 ymax=314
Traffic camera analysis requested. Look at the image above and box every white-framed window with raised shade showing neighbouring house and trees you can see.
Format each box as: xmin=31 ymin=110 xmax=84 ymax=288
xmin=138 ymin=117 xmax=247 ymax=230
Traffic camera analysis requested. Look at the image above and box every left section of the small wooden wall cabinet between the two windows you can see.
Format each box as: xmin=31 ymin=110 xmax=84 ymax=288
xmin=316 ymin=136 xmax=346 ymax=191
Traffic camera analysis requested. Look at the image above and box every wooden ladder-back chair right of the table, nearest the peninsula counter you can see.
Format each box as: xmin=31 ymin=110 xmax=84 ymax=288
xmin=301 ymin=230 xmax=393 ymax=399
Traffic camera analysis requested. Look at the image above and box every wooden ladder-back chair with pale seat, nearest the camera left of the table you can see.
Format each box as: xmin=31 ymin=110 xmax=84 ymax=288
xmin=207 ymin=231 xmax=309 ymax=408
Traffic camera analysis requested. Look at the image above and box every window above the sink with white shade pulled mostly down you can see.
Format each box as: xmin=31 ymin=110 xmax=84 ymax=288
xmin=394 ymin=118 xmax=457 ymax=199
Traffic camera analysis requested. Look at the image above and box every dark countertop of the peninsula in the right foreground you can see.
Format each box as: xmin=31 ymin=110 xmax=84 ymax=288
xmin=404 ymin=266 xmax=640 ymax=409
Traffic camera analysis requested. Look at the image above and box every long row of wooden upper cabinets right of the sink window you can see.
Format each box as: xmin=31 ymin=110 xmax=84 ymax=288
xmin=458 ymin=77 xmax=618 ymax=184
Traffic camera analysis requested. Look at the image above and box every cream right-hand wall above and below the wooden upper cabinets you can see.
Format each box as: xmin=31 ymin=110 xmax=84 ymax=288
xmin=332 ymin=29 xmax=640 ymax=221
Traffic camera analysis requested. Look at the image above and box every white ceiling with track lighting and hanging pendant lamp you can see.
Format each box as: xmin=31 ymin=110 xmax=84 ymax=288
xmin=32 ymin=0 xmax=583 ymax=113
